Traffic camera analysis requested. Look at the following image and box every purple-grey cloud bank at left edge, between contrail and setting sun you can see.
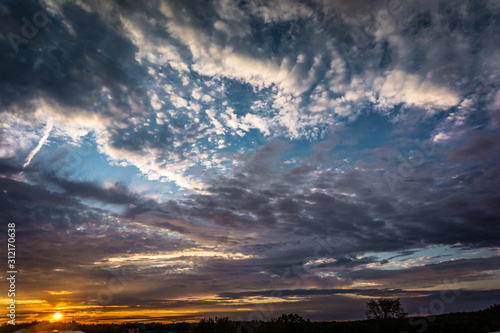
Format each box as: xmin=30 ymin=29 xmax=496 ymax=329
xmin=0 ymin=171 xmax=189 ymax=274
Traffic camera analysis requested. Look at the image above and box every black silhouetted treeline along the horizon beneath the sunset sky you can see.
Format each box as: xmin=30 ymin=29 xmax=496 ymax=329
xmin=0 ymin=305 xmax=500 ymax=333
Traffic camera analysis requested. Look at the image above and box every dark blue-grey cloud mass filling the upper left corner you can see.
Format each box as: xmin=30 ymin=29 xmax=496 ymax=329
xmin=0 ymin=1 xmax=144 ymax=112
